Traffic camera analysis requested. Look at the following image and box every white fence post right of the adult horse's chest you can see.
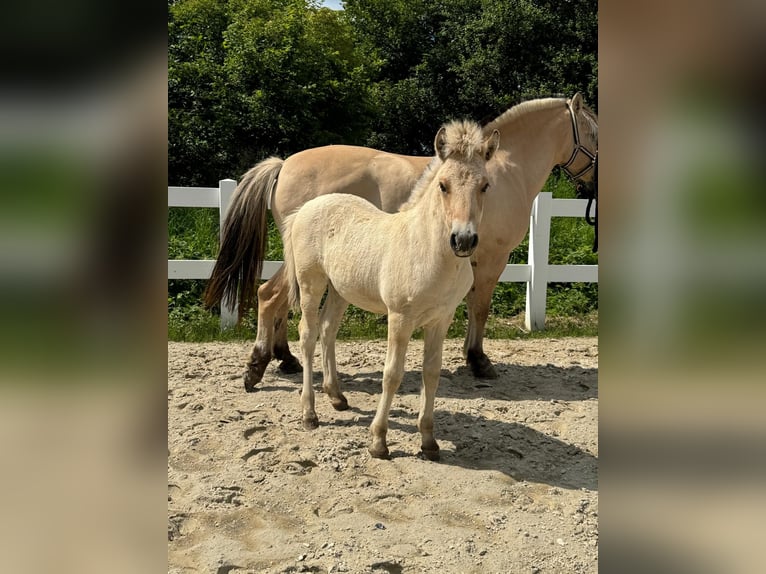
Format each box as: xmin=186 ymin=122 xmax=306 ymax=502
xmin=524 ymin=191 xmax=553 ymax=331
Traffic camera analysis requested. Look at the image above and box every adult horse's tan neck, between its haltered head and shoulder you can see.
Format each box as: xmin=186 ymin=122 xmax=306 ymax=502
xmin=496 ymin=104 xmax=571 ymax=202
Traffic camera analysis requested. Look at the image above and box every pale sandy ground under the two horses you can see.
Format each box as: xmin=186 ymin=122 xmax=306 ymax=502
xmin=168 ymin=338 xmax=598 ymax=574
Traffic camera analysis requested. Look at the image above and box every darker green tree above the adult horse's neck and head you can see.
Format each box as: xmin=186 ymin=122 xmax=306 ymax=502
xmin=345 ymin=0 xmax=597 ymax=153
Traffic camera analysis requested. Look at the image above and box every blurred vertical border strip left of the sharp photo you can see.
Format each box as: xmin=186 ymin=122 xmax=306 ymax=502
xmin=0 ymin=0 xmax=167 ymax=572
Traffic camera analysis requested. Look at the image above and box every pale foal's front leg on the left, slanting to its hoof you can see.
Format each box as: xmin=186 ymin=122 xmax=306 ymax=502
xmin=368 ymin=313 xmax=413 ymax=459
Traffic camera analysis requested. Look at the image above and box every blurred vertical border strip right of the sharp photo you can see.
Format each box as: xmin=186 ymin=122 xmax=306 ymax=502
xmin=599 ymin=0 xmax=766 ymax=574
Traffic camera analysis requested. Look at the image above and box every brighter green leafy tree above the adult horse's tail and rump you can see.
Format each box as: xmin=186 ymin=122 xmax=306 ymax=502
xmin=168 ymin=0 xmax=376 ymax=185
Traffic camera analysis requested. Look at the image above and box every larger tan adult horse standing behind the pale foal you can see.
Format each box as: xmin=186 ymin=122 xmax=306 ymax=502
xmin=205 ymin=94 xmax=598 ymax=391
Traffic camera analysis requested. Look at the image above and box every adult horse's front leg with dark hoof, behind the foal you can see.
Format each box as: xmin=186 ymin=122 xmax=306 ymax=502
xmin=463 ymin=253 xmax=508 ymax=379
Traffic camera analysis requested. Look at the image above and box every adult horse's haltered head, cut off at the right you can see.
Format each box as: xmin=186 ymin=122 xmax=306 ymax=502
xmin=561 ymin=92 xmax=598 ymax=199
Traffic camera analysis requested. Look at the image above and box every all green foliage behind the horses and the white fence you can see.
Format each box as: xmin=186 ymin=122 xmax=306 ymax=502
xmin=168 ymin=0 xmax=598 ymax=342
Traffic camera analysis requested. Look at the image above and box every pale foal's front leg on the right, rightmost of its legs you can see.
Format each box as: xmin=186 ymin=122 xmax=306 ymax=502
xmin=418 ymin=322 xmax=452 ymax=460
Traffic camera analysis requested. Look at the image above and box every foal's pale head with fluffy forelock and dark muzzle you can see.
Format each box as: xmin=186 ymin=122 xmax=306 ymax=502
xmin=434 ymin=120 xmax=500 ymax=257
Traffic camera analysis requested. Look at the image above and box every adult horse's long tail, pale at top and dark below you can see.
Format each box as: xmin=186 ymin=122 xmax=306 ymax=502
xmin=204 ymin=157 xmax=284 ymax=318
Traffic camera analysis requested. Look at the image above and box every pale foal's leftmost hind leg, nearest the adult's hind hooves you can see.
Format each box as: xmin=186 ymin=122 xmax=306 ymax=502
xmin=299 ymin=280 xmax=326 ymax=430
